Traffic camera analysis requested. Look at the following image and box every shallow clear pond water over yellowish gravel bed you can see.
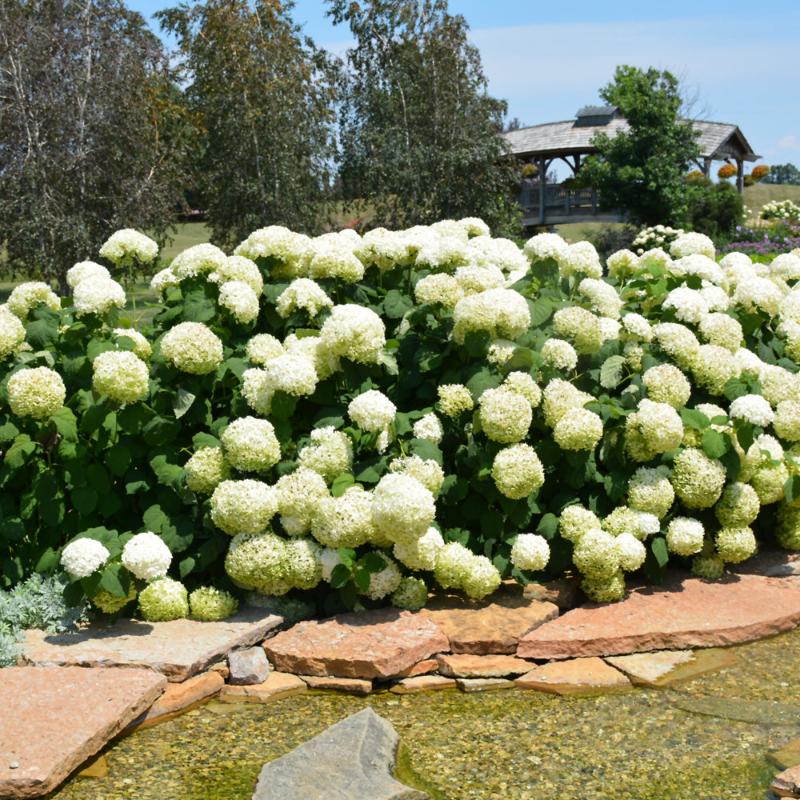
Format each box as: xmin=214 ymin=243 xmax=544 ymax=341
xmin=53 ymin=630 xmax=800 ymax=800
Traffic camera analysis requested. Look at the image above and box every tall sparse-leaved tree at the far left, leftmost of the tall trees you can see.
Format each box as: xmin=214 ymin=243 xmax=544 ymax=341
xmin=0 ymin=0 xmax=191 ymax=285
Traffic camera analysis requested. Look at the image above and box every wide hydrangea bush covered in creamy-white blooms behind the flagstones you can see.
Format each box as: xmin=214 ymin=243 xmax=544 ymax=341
xmin=0 ymin=219 xmax=800 ymax=620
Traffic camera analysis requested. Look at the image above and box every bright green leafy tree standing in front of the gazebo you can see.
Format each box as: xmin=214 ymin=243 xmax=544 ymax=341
xmin=581 ymin=66 xmax=699 ymax=225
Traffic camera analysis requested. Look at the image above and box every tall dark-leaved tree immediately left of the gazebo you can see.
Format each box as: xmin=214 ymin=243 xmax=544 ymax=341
xmin=330 ymin=0 xmax=518 ymax=236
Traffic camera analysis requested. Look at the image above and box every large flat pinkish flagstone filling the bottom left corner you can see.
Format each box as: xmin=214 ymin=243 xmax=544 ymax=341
xmin=0 ymin=667 xmax=167 ymax=798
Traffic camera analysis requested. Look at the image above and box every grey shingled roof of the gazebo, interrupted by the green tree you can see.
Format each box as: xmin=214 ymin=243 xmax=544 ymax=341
xmin=504 ymin=117 xmax=760 ymax=161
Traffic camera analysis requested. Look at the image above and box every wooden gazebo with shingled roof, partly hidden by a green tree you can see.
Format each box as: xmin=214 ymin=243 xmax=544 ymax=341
xmin=505 ymin=106 xmax=760 ymax=226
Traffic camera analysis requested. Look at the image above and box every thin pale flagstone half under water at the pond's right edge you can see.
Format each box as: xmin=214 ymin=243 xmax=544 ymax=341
xmin=606 ymin=648 xmax=738 ymax=686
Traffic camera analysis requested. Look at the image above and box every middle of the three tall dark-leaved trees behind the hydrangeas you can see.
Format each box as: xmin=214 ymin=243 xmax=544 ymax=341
xmin=157 ymin=0 xmax=334 ymax=245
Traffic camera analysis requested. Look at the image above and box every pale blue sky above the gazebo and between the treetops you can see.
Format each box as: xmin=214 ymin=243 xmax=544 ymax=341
xmin=129 ymin=0 xmax=800 ymax=170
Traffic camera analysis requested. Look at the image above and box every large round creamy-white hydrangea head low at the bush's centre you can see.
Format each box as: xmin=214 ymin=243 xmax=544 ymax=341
xmin=372 ymin=473 xmax=436 ymax=543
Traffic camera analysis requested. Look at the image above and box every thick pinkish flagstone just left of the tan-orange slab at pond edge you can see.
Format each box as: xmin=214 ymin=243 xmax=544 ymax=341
xmin=264 ymin=608 xmax=449 ymax=680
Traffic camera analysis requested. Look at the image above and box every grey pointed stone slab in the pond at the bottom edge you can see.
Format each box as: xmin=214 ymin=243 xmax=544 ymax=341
xmin=253 ymin=708 xmax=428 ymax=800
